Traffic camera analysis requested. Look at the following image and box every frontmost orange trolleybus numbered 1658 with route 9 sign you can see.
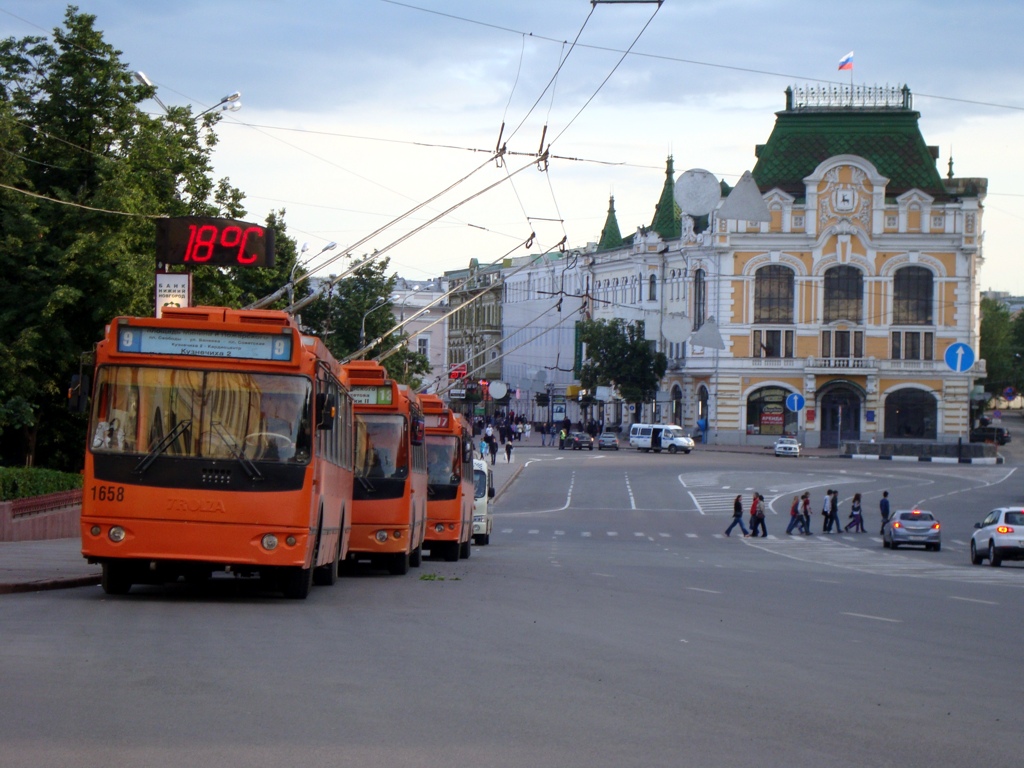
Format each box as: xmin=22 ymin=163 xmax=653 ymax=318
xmin=82 ymin=307 xmax=353 ymax=599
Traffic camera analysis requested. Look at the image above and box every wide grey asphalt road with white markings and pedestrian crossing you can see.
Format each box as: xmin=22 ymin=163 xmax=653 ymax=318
xmin=0 ymin=447 xmax=1024 ymax=768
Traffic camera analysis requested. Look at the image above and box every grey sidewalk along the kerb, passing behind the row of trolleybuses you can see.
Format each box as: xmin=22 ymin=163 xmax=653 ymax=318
xmin=0 ymin=456 xmax=528 ymax=595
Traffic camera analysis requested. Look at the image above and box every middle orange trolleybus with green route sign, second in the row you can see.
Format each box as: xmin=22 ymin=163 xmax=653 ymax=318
xmin=341 ymin=360 xmax=427 ymax=575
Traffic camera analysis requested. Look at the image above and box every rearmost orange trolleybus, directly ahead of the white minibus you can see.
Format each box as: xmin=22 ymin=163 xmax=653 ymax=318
xmin=420 ymin=394 xmax=473 ymax=562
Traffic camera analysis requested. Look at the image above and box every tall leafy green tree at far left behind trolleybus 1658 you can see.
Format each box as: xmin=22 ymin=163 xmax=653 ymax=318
xmin=0 ymin=6 xmax=242 ymax=468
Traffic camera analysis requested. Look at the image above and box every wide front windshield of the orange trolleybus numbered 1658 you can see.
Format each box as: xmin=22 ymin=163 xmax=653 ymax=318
xmin=89 ymin=366 xmax=312 ymax=463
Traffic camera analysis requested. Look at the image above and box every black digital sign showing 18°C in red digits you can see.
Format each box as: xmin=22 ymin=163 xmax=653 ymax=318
xmin=157 ymin=216 xmax=273 ymax=266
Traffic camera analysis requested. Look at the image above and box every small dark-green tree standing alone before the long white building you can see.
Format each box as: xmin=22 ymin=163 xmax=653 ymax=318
xmin=580 ymin=317 xmax=669 ymax=417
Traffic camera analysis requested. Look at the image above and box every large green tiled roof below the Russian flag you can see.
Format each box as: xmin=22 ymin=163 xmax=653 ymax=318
xmin=752 ymin=109 xmax=946 ymax=198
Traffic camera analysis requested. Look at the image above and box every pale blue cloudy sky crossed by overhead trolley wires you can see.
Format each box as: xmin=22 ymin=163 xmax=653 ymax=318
xmin=0 ymin=0 xmax=1024 ymax=295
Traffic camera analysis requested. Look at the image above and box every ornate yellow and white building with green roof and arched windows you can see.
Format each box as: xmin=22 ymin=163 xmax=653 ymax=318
xmin=586 ymin=87 xmax=987 ymax=446
